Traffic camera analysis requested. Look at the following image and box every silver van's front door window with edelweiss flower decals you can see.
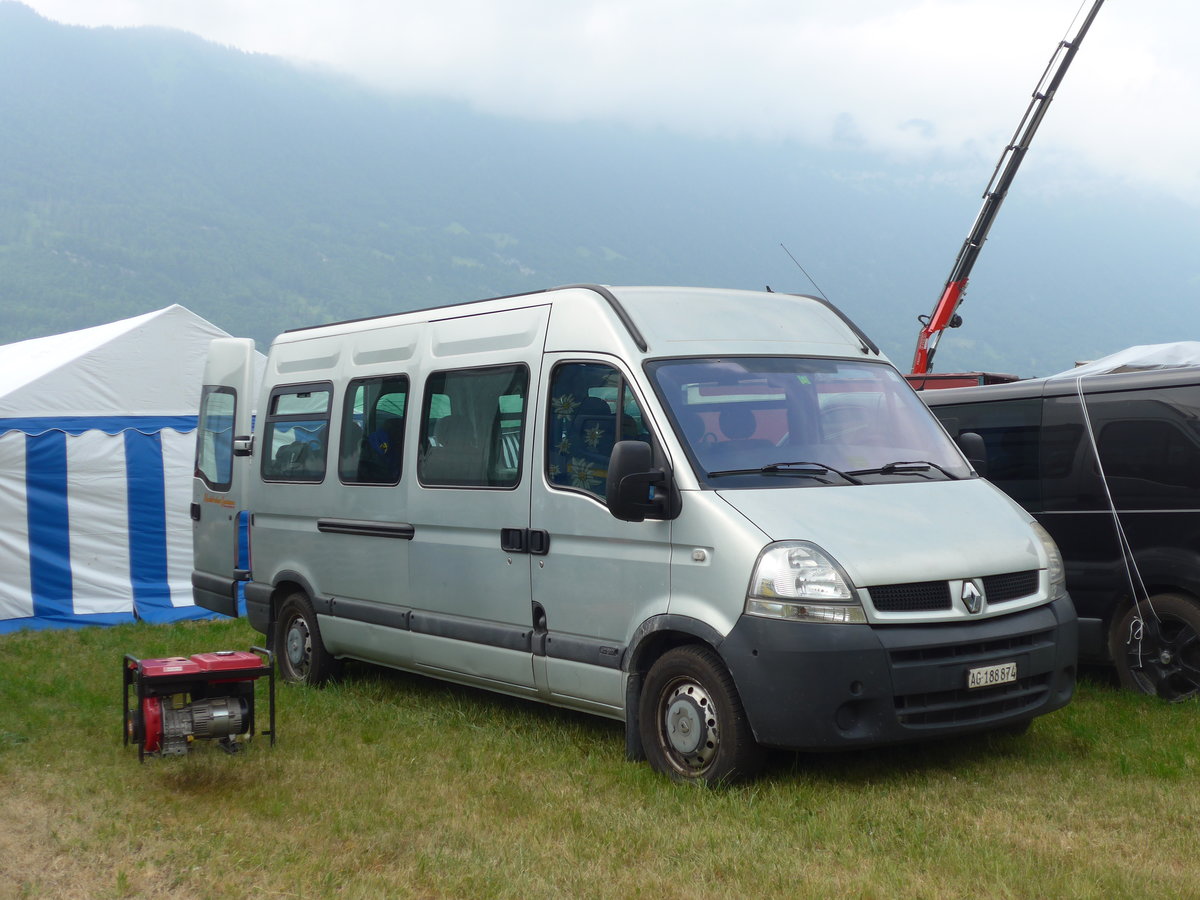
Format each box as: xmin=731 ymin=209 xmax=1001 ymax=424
xmin=546 ymin=362 xmax=650 ymax=499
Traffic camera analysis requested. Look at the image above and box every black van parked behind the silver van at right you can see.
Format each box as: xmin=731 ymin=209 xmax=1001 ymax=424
xmin=922 ymin=367 xmax=1200 ymax=700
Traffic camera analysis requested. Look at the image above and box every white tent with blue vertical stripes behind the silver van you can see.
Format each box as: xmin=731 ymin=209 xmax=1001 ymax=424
xmin=0 ymin=305 xmax=255 ymax=634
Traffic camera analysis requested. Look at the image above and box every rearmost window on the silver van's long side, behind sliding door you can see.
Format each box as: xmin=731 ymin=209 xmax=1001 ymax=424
xmin=263 ymin=384 xmax=331 ymax=482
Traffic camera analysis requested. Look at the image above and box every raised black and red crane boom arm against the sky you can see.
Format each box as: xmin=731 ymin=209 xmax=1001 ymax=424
xmin=912 ymin=0 xmax=1104 ymax=374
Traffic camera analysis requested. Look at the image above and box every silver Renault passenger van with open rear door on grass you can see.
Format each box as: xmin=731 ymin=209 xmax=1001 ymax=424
xmin=192 ymin=286 xmax=1076 ymax=782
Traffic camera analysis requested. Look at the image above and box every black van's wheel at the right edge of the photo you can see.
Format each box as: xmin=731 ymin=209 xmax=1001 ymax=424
xmin=1109 ymin=594 xmax=1200 ymax=702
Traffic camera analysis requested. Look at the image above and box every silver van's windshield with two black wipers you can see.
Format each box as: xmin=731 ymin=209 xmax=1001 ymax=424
xmin=647 ymin=356 xmax=971 ymax=488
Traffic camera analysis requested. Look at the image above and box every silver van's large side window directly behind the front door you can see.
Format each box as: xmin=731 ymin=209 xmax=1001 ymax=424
xmin=416 ymin=366 xmax=529 ymax=487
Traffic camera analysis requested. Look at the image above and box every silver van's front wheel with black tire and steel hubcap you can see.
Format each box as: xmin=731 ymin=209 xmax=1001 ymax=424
xmin=637 ymin=644 xmax=766 ymax=785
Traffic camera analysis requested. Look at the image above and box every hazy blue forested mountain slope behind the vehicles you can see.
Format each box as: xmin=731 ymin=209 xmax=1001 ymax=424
xmin=0 ymin=2 xmax=1200 ymax=376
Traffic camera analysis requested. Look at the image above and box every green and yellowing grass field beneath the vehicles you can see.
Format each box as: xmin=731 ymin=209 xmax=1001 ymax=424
xmin=0 ymin=622 xmax=1200 ymax=898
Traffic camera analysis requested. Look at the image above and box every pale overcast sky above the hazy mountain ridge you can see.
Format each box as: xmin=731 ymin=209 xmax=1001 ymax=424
xmin=16 ymin=0 xmax=1200 ymax=205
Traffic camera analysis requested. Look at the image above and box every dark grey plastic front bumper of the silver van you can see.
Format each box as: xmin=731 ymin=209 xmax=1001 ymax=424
xmin=720 ymin=596 xmax=1078 ymax=750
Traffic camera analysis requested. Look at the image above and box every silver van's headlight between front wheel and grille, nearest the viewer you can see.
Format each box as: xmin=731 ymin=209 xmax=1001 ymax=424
xmin=745 ymin=542 xmax=866 ymax=624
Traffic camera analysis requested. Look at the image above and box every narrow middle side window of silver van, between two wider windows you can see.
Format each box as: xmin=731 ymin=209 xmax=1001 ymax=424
xmin=337 ymin=376 xmax=408 ymax=485
